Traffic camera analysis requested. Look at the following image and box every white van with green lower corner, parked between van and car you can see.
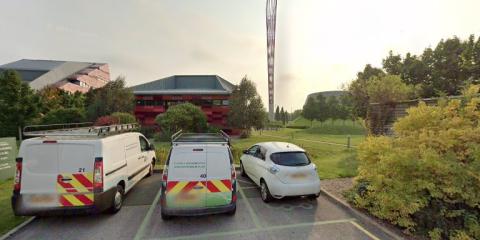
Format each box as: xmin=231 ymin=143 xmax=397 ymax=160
xmin=160 ymin=132 xmax=237 ymax=220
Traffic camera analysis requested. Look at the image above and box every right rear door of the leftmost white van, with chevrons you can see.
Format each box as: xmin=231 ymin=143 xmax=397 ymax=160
xmin=57 ymin=143 xmax=95 ymax=207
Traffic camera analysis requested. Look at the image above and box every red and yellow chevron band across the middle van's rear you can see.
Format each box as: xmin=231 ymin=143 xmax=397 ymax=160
xmin=166 ymin=179 xmax=232 ymax=194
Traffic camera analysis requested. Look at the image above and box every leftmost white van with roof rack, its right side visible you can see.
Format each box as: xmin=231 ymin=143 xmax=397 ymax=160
xmin=12 ymin=124 xmax=155 ymax=215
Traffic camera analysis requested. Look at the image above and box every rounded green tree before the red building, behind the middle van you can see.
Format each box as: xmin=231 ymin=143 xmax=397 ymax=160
xmin=155 ymin=103 xmax=207 ymax=133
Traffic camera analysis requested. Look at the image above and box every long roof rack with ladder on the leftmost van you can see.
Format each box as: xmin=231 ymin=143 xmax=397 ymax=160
xmin=23 ymin=122 xmax=138 ymax=137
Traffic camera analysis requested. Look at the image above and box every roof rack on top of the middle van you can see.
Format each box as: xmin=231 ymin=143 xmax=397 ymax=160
xmin=171 ymin=130 xmax=230 ymax=146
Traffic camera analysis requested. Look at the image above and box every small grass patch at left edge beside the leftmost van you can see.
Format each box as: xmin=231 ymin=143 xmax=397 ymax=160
xmin=0 ymin=179 xmax=28 ymax=236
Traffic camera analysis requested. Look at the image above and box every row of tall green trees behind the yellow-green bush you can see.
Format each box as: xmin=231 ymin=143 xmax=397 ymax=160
xmin=346 ymin=35 xmax=480 ymax=118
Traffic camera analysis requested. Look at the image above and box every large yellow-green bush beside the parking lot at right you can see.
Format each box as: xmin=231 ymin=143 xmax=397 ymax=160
xmin=353 ymin=87 xmax=480 ymax=239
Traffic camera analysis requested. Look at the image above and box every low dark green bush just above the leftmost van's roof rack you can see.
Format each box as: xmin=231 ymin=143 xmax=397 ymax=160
xmin=41 ymin=108 xmax=85 ymax=124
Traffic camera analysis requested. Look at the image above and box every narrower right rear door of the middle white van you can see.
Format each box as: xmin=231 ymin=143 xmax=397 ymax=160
xmin=206 ymin=145 xmax=232 ymax=207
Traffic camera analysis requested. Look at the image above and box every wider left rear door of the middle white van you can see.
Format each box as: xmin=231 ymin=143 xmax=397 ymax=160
xmin=166 ymin=144 xmax=207 ymax=208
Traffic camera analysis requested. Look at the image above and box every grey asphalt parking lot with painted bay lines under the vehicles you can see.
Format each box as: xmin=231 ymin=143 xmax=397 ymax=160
xmin=9 ymin=174 xmax=396 ymax=240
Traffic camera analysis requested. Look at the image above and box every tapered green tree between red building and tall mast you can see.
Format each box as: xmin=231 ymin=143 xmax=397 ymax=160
xmin=228 ymin=77 xmax=267 ymax=136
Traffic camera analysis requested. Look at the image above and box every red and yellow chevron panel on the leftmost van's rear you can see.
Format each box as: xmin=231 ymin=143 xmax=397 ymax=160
xmin=57 ymin=173 xmax=93 ymax=207
